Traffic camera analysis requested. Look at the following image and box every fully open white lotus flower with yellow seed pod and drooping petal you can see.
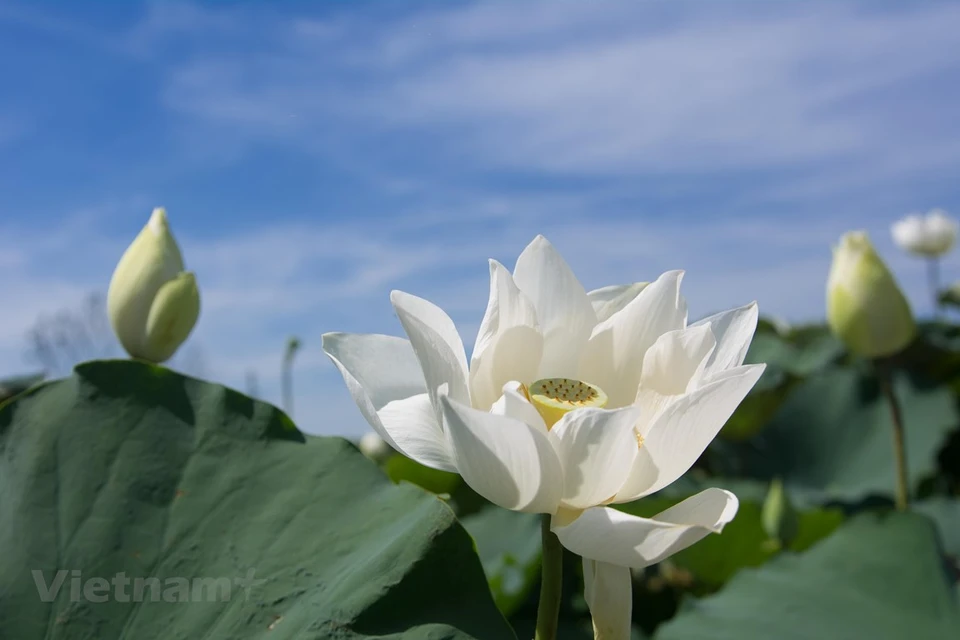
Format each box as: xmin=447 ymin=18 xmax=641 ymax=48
xmin=323 ymin=236 xmax=763 ymax=638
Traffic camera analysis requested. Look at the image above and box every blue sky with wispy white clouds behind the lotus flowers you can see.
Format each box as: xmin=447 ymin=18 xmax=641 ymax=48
xmin=0 ymin=0 xmax=960 ymax=435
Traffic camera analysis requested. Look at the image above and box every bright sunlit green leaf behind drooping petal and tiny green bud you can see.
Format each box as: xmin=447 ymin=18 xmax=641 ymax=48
xmin=617 ymin=480 xmax=843 ymax=593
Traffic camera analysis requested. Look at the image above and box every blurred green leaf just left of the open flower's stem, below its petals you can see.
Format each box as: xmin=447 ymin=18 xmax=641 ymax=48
xmin=461 ymin=506 xmax=541 ymax=616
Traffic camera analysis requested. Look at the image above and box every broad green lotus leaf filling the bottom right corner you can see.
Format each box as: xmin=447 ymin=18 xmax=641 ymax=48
xmin=656 ymin=513 xmax=960 ymax=640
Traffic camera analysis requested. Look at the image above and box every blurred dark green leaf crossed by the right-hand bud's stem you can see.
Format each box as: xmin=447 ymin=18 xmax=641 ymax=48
xmin=728 ymin=367 xmax=958 ymax=501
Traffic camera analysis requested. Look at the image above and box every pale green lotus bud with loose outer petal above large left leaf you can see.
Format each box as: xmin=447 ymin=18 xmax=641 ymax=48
xmin=107 ymin=208 xmax=200 ymax=363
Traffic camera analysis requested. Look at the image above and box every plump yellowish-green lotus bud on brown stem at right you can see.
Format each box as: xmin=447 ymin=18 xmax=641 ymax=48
xmin=827 ymin=231 xmax=917 ymax=358
